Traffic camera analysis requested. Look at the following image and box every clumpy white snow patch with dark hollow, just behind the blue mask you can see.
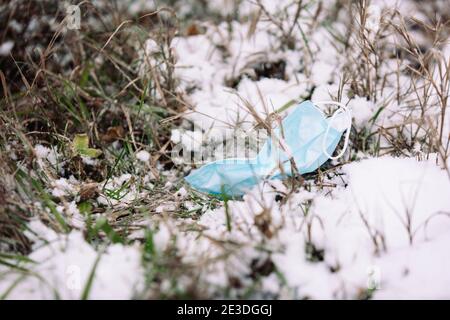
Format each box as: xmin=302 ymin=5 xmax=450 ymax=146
xmin=173 ymin=17 xmax=307 ymax=139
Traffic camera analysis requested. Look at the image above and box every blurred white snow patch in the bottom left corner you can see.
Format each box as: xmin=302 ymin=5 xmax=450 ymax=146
xmin=0 ymin=224 xmax=143 ymax=300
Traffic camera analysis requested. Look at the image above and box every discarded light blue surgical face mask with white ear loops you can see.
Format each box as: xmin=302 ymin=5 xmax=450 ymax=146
xmin=185 ymin=101 xmax=351 ymax=196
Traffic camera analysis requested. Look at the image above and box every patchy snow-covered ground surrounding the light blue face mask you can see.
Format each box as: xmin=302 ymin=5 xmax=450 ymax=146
xmin=0 ymin=0 xmax=450 ymax=299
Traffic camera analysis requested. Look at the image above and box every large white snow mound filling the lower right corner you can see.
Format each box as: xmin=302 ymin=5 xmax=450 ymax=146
xmin=312 ymin=157 xmax=450 ymax=298
